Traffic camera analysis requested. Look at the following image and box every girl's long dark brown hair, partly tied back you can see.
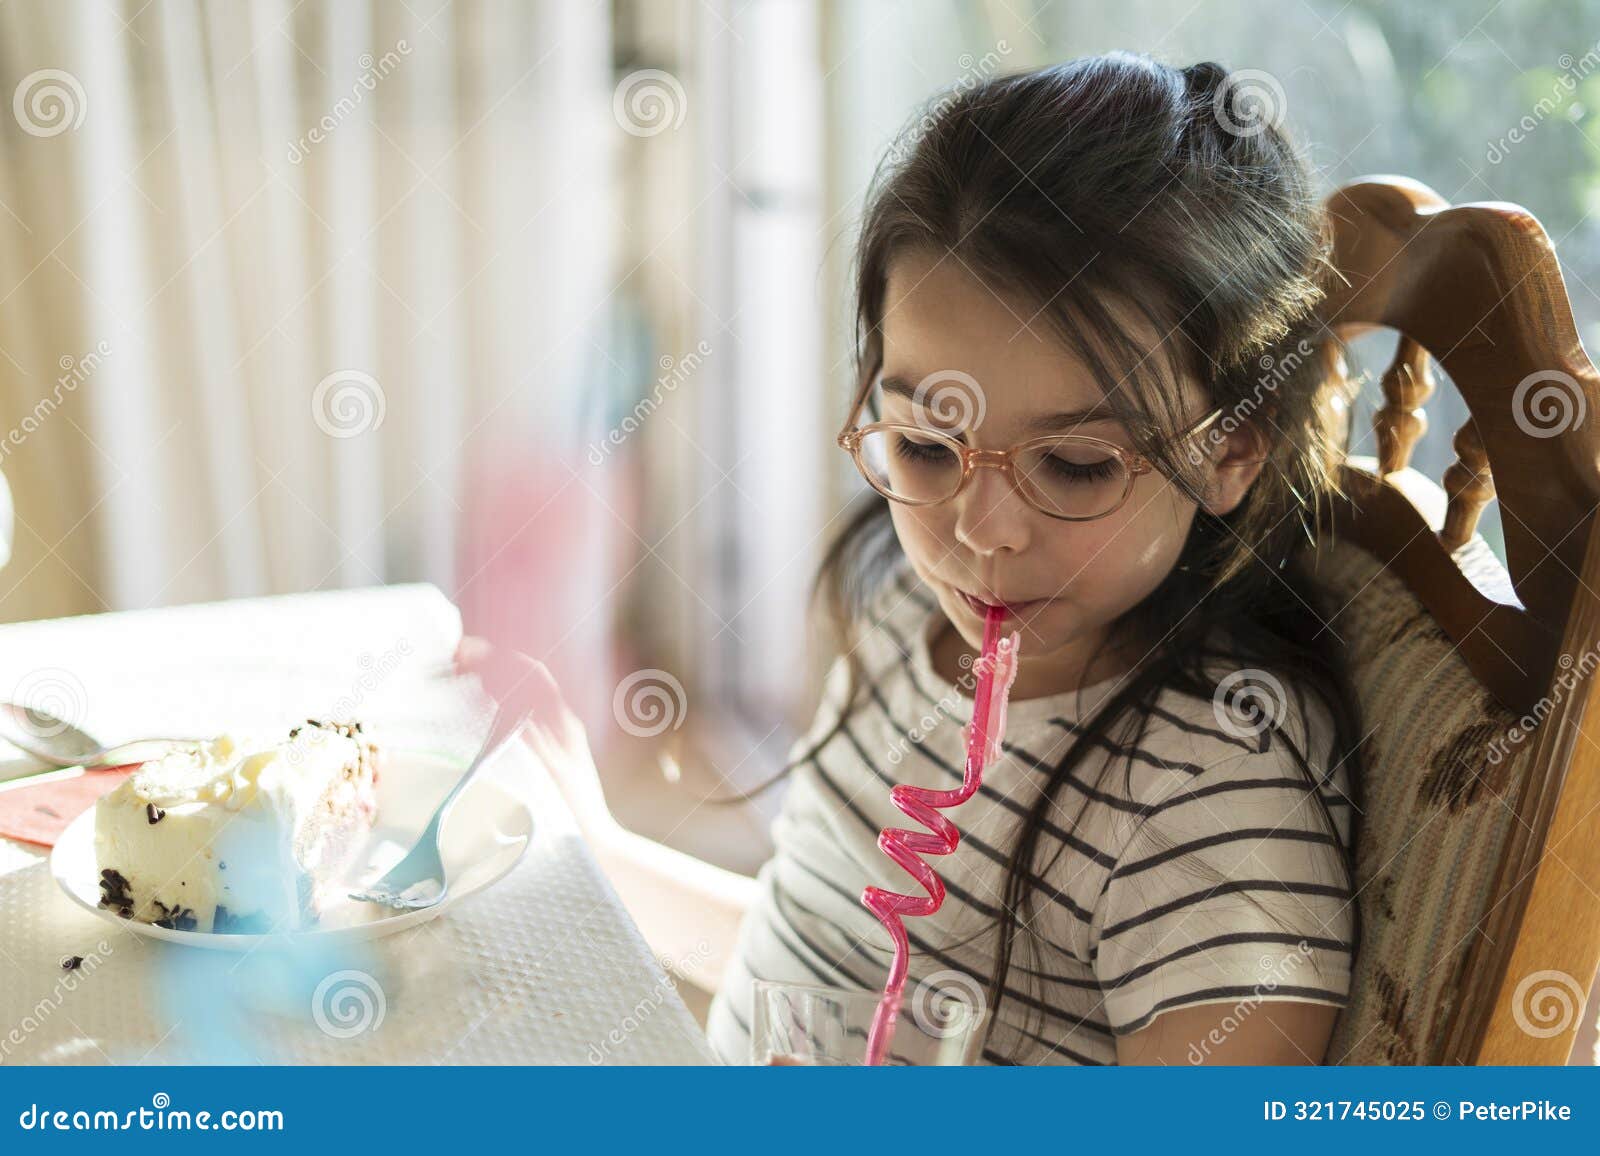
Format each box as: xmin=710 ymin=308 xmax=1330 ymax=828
xmin=736 ymin=53 xmax=1362 ymax=1056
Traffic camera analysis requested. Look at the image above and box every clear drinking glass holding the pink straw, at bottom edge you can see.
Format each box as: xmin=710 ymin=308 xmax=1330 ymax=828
xmin=750 ymin=980 xmax=989 ymax=1066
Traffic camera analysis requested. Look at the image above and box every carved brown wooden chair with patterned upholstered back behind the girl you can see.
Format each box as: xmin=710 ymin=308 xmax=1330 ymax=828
xmin=1312 ymin=176 xmax=1600 ymax=1065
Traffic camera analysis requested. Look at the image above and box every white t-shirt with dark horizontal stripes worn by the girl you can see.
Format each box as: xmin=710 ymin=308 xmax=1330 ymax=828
xmin=707 ymin=560 xmax=1354 ymax=1065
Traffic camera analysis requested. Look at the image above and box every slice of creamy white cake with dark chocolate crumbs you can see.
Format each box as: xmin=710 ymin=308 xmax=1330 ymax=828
xmin=94 ymin=719 xmax=378 ymax=932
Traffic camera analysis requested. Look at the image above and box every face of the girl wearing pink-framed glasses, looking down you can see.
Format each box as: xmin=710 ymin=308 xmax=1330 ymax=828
xmin=878 ymin=251 xmax=1259 ymax=700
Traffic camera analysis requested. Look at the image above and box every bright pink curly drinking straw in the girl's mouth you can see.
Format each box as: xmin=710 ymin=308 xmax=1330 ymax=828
xmin=861 ymin=605 xmax=1022 ymax=1065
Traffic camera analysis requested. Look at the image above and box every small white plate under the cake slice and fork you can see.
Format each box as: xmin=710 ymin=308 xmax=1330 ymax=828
xmin=50 ymin=751 xmax=533 ymax=951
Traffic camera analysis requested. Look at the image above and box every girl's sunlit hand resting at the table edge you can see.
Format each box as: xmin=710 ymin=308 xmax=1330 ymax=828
xmin=454 ymin=637 xmax=616 ymax=836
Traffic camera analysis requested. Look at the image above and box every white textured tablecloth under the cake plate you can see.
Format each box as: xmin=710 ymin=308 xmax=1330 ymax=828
xmin=0 ymin=586 xmax=715 ymax=1063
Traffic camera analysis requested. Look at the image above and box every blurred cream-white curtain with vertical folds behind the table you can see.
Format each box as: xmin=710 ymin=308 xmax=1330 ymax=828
xmin=0 ymin=0 xmax=624 ymax=720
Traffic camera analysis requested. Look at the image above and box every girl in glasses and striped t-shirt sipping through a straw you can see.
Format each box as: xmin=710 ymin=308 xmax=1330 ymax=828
xmin=470 ymin=53 xmax=1360 ymax=1065
